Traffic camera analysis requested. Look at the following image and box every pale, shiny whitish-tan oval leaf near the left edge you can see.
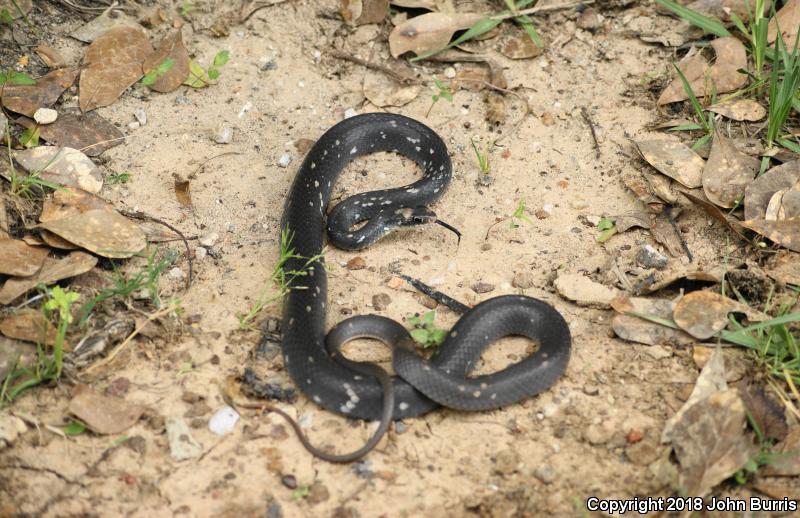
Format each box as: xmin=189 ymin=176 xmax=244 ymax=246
xmin=14 ymin=146 xmax=103 ymax=194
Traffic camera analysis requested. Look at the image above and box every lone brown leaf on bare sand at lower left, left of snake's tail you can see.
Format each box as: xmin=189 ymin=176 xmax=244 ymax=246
xmin=69 ymin=385 xmax=146 ymax=435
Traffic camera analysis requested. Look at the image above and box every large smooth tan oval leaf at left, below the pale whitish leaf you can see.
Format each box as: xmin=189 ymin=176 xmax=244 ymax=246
xmin=39 ymin=210 xmax=147 ymax=258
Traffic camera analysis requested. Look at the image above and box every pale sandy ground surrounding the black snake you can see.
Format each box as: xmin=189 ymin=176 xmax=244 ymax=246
xmin=0 ymin=0 xmax=796 ymax=517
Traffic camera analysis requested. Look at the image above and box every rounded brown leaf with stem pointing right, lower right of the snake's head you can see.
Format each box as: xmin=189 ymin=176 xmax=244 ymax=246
xmin=673 ymin=290 xmax=764 ymax=340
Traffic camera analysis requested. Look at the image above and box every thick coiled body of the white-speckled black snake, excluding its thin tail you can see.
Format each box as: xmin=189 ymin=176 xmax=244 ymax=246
xmin=281 ymin=113 xmax=570 ymax=434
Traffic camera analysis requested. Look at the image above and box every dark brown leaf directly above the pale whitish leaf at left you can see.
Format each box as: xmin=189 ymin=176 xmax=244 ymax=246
xmin=16 ymin=110 xmax=124 ymax=156
